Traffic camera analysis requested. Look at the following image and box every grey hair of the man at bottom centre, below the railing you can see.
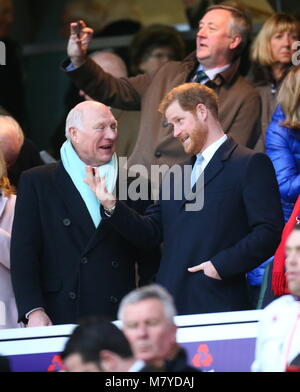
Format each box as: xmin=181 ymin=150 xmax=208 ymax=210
xmin=118 ymin=284 xmax=177 ymax=323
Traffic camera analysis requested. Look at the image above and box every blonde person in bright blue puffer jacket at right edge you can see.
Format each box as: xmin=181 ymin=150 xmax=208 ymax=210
xmin=248 ymin=65 xmax=300 ymax=304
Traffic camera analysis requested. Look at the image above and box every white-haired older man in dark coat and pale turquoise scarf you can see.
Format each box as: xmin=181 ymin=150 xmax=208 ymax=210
xmin=11 ymin=101 xmax=159 ymax=326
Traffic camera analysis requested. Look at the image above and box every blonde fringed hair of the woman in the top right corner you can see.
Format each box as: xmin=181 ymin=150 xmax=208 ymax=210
xmin=251 ymin=13 xmax=300 ymax=66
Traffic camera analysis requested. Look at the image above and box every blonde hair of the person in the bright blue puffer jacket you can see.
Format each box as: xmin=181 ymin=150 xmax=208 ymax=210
xmin=277 ymin=66 xmax=300 ymax=129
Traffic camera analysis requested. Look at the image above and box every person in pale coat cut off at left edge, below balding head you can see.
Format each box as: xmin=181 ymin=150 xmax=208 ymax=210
xmin=0 ymin=150 xmax=19 ymax=329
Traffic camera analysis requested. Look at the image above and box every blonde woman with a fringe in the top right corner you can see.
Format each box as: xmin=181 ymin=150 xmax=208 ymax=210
xmin=248 ymin=13 xmax=300 ymax=151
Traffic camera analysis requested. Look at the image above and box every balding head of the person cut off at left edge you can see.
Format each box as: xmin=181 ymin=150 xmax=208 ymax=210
xmin=0 ymin=115 xmax=24 ymax=167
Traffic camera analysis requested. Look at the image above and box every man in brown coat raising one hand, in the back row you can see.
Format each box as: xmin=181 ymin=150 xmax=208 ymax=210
xmin=63 ymin=5 xmax=260 ymax=179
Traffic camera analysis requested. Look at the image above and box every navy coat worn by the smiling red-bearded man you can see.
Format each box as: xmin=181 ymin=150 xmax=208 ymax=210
xmin=107 ymin=138 xmax=283 ymax=314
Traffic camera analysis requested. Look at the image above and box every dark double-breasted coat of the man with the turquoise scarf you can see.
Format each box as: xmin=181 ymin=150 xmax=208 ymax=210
xmin=11 ymin=162 xmax=159 ymax=324
